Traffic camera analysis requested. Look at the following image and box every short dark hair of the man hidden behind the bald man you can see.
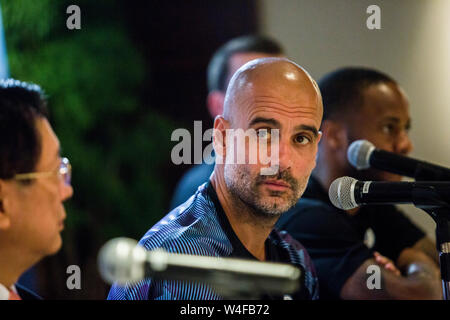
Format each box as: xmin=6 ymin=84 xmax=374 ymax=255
xmin=207 ymin=35 xmax=283 ymax=92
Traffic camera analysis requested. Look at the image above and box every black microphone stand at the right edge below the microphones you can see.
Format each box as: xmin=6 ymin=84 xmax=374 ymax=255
xmin=413 ymin=188 xmax=450 ymax=300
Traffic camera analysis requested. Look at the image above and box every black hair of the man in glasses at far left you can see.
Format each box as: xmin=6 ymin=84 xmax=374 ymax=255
xmin=0 ymin=79 xmax=47 ymax=180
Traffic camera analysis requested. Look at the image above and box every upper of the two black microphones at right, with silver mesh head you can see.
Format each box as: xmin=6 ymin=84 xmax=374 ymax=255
xmin=347 ymin=140 xmax=450 ymax=181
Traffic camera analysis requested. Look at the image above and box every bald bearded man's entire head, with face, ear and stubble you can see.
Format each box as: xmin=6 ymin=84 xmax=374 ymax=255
xmin=213 ymin=58 xmax=323 ymax=220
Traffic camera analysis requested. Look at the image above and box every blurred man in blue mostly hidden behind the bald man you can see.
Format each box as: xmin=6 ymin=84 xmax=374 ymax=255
xmin=170 ymin=35 xmax=284 ymax=209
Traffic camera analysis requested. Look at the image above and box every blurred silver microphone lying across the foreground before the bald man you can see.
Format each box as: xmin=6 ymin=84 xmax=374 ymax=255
xmin=98 ymin=238 xmax=304 ymax=299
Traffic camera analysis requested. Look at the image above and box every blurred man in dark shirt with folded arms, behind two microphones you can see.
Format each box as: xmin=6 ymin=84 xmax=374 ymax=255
xmin=278 ymin=68 xmax=441 ymax=299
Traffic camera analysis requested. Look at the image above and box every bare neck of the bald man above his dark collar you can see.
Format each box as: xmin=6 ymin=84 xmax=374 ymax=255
xmin=211 ymin=171 xmax=277 ymax=261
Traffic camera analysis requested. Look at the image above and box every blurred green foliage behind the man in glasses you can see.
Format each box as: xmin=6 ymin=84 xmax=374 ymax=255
xmin=1 ymin=0 xmax=175 ymax=298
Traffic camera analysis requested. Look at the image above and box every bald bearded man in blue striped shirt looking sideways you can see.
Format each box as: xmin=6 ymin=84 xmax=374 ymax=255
xmin=108 ymin=58 xmax=322 ymax=300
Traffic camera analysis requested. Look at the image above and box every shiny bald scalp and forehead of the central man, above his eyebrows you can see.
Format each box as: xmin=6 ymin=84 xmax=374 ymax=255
xmin=223 ymin=58 xmax=323 ymax=124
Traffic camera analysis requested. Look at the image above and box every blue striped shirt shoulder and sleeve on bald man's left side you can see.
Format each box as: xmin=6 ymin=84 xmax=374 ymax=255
xmin=108 ymin=188 xmax=232 ymax=300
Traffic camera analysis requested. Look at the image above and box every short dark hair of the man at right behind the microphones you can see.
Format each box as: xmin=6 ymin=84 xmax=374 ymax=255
xmin=318 ymin=67 xmax=397 ymax=120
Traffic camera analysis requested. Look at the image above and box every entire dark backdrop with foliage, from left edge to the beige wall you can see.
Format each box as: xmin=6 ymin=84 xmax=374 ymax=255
xmin=1 ymin=0 xmax=259 ymax=299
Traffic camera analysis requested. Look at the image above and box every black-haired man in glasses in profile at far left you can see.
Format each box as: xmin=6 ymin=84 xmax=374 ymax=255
xmin=0 ymin=79 xmax=73 ymax=300
